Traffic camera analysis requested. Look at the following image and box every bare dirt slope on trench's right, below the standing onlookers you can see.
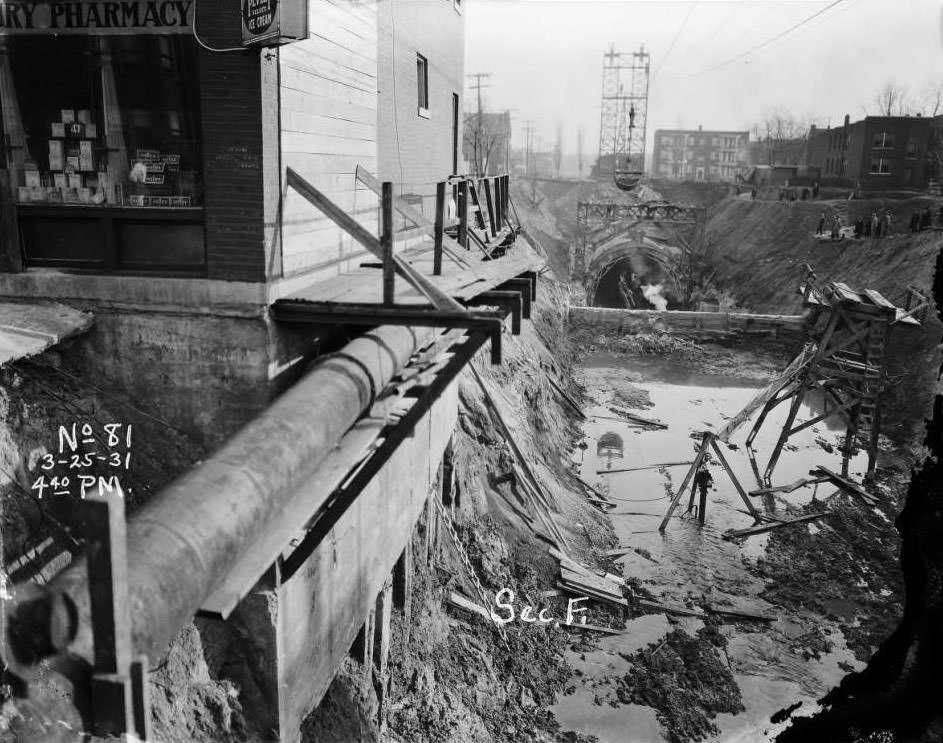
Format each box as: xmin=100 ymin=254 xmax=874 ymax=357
xmin=706 ymin=197 xmax=943 ymax=444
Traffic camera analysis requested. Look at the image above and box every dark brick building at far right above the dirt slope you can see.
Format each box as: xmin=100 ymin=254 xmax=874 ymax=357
xmin=806 ymin=116 xmax=943 ymax=191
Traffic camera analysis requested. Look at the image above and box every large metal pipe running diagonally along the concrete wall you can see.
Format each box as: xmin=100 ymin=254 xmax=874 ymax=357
xmin=11 ymin=326 xmax=435 ymax=663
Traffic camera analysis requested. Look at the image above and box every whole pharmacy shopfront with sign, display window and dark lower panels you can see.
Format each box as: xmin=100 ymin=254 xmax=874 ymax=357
xmin=0 ymin=0 xmax=206 ymax=275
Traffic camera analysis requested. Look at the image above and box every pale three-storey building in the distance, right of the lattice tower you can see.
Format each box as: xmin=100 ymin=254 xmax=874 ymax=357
xmin=652 ymin=127 xmax=750 ymax=181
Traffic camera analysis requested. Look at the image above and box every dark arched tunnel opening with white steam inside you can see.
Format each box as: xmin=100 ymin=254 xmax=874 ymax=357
xmin=589 ymin=253 xmax=679 ymax=310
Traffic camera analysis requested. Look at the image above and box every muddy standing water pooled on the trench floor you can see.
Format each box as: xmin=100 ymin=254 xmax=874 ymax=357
xmin=554 ymin=354 xmax=866 ymax=743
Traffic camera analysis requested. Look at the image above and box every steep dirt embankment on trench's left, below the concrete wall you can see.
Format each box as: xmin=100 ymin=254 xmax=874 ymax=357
xmin=306 ymin=280 xmax=613 ymax=743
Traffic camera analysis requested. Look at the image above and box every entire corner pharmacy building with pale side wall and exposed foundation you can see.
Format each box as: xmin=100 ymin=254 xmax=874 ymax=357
xmin=0 ymin=0 xmax=464 ymax=446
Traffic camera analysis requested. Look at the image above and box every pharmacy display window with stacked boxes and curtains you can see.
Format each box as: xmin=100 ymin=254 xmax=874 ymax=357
xmin=0 ymin=36 xmax=202 ymax=208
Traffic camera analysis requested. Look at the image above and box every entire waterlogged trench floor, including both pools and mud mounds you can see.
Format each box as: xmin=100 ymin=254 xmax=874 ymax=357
xmin=558 ymin=335 xmax=906 ymax=742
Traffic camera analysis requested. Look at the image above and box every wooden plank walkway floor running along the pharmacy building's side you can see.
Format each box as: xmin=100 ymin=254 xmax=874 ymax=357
xmin=278 ymin=238 xmax=545 ymax=306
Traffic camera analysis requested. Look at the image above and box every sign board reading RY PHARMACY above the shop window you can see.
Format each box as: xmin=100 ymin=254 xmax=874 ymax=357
xmin=0 ymin=0 xmax=194 ymax=36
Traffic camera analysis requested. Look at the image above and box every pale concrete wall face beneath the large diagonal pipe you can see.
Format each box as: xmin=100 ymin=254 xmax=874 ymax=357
xmin=277 ymin=383 xmax=458 ymax=743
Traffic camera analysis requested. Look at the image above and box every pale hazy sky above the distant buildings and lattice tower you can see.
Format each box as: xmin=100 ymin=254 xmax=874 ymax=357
xmin=463 ymin=0 xmax=943 ymax=154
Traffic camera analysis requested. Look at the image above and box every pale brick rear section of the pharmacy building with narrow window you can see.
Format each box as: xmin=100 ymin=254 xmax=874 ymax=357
xmin=377 ymin=0 xmax=465 ymax=216
